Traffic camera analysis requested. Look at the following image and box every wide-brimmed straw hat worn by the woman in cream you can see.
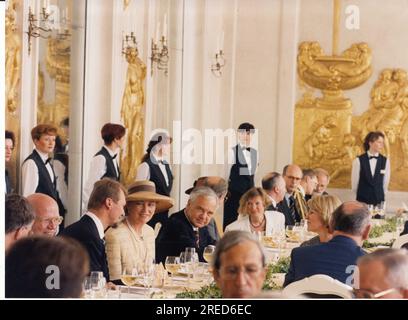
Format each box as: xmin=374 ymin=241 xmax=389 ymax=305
xmin=126 ymin=180 xmax=174 ymax=212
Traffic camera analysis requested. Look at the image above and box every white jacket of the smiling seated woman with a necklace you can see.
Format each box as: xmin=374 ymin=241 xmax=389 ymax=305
xmin=225 ymin=211 xmax=285 ymax=236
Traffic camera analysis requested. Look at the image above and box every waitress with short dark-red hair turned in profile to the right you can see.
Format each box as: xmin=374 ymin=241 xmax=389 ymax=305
xmin=82 ymin=123 xmax=126 ymax=211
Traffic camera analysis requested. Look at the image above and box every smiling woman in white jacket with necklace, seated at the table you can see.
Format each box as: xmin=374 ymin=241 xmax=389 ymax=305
xmin=225 ymin=187 xmax=285 ymax=236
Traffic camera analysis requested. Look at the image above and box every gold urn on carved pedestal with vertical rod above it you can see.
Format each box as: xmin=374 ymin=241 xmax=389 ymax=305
xmin=293 ymin=0 xmax=372 ymax=188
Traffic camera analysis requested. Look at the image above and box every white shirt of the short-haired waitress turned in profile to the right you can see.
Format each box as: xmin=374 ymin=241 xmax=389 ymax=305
xmin=82 ymin=146 xmax=119 ymax=210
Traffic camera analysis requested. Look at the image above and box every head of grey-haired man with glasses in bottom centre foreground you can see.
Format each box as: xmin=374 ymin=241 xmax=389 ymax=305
xmin=213 ymin=230 xmax=266 ymax=298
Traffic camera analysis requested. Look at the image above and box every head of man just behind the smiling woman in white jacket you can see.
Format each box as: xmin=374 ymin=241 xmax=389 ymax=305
xmin=262 ymin=172 xmax=286 ymax=211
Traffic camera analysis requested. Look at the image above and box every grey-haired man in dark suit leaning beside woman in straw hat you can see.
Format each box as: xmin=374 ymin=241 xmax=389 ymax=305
xmin=156 ymin=187 xmax=218 ymax=263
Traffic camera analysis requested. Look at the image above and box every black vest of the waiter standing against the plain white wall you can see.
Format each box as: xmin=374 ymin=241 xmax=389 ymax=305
xmin=228 ymin=145 xmax=258 ymax=194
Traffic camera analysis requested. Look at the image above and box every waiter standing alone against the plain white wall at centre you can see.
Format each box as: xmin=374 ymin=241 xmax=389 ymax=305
xmin=223 ymin=122 xmax=258 ymax=230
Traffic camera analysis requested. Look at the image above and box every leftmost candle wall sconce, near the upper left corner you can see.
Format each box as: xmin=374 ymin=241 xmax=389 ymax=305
xmin=26 ymin=4 xmax=71 ymax=54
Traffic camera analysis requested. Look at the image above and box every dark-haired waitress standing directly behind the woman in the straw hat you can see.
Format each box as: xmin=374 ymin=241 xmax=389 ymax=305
xmin=136 ymin=132 xmax=173 ymax=228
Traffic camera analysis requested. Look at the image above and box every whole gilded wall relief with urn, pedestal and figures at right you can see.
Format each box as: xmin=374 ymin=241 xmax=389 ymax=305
xmin=293 ymin=42 xmax=408 ymax=191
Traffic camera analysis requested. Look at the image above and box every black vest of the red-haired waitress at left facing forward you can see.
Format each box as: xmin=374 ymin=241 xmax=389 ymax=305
xmin=24 ymin=150 xmax=65 ymax=216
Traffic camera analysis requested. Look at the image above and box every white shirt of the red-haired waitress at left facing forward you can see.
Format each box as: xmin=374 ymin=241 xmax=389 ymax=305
xmin=21 ymin=148 xmax=55 ymax=197
